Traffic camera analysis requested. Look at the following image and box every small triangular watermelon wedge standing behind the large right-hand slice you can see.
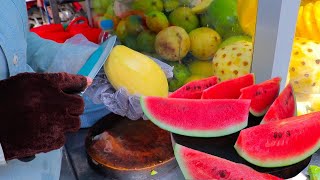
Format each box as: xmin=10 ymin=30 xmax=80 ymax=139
xmin=261 ymin=84 xmax=296 ymax=124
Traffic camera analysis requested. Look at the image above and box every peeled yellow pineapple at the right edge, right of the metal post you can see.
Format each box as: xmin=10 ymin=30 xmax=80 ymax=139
xmin=289 ymin=38 xmax=320 ymax=94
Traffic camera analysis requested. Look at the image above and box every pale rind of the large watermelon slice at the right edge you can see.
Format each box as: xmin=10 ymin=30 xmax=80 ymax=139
xmin=234 ymin=139 xmax=320 ymax=168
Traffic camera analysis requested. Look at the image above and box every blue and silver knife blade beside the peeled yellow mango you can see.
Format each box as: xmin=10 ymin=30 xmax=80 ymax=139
xmin=77 ymin=36 xmax=117 ymax=96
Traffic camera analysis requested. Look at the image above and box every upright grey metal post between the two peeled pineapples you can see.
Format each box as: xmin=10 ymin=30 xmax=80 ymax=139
xmin=251 ymin=0 xmax=300 ymax=89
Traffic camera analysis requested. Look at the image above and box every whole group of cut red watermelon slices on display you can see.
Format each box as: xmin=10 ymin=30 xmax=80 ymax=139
xmin=141 ymin=74 xmax=320 ymax=179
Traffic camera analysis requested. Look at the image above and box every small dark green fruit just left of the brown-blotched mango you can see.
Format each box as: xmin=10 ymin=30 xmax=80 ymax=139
xmin=137 ymin=31 xmax=156 ymax=53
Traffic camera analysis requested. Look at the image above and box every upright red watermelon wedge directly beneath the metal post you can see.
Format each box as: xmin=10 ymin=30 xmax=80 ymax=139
xmin=239 ymin=77 xmax=281 ymax=117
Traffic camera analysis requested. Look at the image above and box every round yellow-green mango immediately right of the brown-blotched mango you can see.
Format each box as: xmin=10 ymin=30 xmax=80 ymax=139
xmin=189 ymin=27 xmax=221 ymax=60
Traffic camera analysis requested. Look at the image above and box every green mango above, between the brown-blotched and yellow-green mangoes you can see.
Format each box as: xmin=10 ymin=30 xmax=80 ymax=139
xmin=169 ymin=7 xmax=199 ymax=33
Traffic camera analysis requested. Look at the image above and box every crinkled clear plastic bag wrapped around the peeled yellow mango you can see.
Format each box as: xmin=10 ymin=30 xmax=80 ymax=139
xmin=85 ymin=57 xmax=173 ymax=120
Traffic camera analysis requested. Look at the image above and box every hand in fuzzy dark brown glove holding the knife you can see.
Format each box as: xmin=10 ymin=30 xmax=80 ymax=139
xmin=0 ymin=73 xmax=90 ymax=160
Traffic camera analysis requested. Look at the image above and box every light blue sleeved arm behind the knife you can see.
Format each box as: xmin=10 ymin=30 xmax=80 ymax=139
xmin=27 ymin=32 xmax=98 ymax=74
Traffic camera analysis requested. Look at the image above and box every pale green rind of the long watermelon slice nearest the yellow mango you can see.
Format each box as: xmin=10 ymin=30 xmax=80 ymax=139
xmin=140 ymin=96 xmax=248 ymax=137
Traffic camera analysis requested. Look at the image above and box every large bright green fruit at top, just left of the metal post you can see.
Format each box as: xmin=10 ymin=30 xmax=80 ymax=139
xmin=207 ymin=0 xmax=243 ymax=39
